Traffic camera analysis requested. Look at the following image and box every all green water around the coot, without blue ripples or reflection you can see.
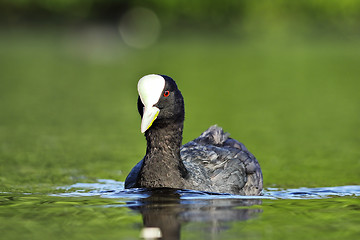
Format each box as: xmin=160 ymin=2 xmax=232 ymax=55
xmin=0 ymin=28 xmax=360 ymax=239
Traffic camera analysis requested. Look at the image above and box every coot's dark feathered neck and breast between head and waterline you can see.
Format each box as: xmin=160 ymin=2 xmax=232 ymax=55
xmin=138 ymin=121 xmax=187 ymax=188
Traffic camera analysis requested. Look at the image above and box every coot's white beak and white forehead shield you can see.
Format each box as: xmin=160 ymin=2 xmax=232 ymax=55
xmin=138 ymin=74 xmax=165 ymax=133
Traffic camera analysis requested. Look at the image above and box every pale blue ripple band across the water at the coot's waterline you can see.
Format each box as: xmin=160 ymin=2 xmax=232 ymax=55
xmin=54 ymin=179 xmax=360 ymax=200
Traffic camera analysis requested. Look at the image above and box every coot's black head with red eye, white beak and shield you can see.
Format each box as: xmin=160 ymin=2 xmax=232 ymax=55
xmin=138 ymin=74 xmax=185 ymax=133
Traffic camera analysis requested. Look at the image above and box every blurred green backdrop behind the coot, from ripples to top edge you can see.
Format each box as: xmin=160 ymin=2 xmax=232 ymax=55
xmin=0 ymin=0 xmax=360 ymax=192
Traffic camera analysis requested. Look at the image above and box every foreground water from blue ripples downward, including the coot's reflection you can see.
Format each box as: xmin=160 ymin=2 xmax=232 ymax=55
xmin=0 ymin=179 xmax=360 ymax=239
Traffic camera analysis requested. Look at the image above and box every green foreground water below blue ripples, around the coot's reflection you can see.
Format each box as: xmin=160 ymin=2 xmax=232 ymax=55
xmin=0 ymin=194 xmax=360 ymax=239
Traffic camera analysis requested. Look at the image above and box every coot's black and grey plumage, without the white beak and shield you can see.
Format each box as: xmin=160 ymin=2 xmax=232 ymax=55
xmin=125 ymin=75 xmax=263 ymax=195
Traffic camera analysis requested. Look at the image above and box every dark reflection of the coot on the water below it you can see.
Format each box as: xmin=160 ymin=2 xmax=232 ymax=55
xmin=131 ymin=189 xmax=261 ymax=239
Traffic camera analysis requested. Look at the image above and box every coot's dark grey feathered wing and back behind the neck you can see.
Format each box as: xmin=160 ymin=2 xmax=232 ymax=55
xmin=181 ymin=125 xmax=263 ymax=195
